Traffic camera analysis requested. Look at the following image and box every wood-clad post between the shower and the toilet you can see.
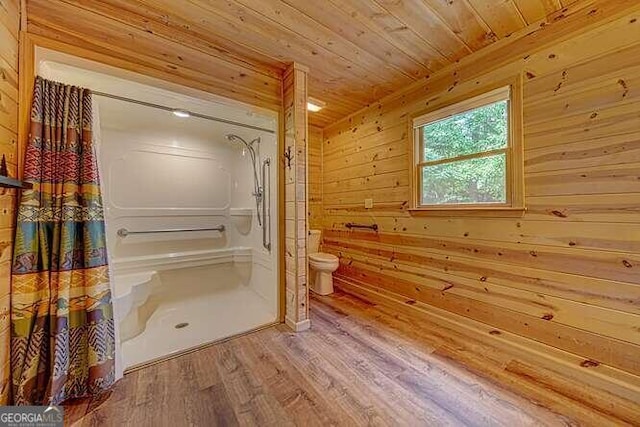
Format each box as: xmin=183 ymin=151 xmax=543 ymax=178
xmin=282 ymin=64 xmax=310 ymax=331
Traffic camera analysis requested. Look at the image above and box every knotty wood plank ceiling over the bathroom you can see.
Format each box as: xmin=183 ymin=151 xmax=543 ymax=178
xmin=28 ymin=0 xmax=572 ymax=127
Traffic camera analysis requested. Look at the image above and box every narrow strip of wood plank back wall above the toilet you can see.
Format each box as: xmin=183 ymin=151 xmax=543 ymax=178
xmin=307 ymin=126 xmax=322 ymax=230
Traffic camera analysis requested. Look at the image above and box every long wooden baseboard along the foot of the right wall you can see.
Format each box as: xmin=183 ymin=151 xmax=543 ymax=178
xmin=334 ymin=277 xmax=640 ymax=405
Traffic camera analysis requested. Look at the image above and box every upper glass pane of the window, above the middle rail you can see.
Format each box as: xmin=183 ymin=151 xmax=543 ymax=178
xmin=422 ymin=100 xmax=508 ymax=161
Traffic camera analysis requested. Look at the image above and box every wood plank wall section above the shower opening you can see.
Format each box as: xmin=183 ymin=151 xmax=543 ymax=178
xmin=27 ymin=0 xmax=282 ymax=111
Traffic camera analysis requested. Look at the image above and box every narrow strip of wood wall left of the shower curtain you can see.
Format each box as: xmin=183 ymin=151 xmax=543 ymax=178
xmin=0 ymin=0 xmax=20 ymax=405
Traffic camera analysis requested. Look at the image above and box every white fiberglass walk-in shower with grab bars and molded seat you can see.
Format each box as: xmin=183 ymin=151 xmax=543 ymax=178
xmin=36 ymin=49 xmax=280 ymax=373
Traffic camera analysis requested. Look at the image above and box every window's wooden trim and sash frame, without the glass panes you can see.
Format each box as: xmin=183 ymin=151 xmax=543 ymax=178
xmin=410 ymin=76 xmax=525 ymax=216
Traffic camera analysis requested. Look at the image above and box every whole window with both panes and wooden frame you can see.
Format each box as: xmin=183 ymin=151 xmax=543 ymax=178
xmin=413 ymin=79 xmax=524 ymax=210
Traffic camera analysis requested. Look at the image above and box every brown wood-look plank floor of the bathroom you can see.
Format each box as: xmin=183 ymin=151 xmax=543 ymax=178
xmin=65 ymin=292 xmax=636 ymax=427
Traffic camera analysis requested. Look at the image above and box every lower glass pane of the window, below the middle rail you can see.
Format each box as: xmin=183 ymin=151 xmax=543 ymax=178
xmin=422 ymin=153 xmax=507 ymax=205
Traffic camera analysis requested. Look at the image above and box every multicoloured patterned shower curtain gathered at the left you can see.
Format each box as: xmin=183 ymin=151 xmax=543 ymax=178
xmin=11 ymin=77 xmax=115 ymax=405
